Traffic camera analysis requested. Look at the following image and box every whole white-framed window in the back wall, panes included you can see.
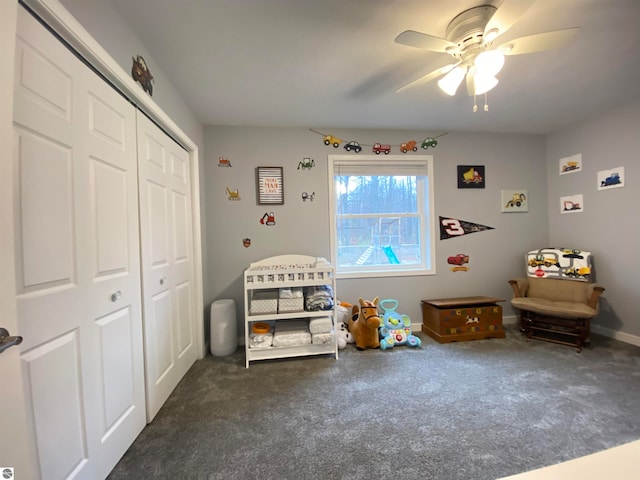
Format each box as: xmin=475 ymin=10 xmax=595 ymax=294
xmin=329 ymin=155 xmax=435 ymax=278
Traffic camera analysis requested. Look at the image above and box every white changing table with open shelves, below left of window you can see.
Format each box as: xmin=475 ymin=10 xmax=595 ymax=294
xmin=244 ymin=255 xmax=338 ymax=368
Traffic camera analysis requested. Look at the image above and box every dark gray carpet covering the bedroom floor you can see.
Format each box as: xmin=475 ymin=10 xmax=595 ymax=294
xmin=109 ymin=326 xmax=640 ymax=480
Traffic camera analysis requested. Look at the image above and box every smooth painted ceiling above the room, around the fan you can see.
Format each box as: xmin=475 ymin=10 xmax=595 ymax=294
xmin=107 ymin=0 xmax=640 ymax=135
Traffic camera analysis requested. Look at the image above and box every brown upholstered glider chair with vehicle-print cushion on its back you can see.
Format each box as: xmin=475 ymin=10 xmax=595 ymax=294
xmin=509 ymin=248 xmax=605 ymax=352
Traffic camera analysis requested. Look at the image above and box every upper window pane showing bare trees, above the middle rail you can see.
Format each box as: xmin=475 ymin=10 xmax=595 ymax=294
xmin=335 ymin=175 xmax=419 ymax=215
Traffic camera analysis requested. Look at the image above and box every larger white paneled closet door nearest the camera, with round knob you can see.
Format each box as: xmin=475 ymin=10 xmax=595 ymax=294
xmin=14 ymin=8 xmax=145 ymax=479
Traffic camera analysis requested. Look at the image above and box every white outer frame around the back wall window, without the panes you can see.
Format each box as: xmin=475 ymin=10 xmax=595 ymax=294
xmin=327 ymin=154 xmax=436 ymax=278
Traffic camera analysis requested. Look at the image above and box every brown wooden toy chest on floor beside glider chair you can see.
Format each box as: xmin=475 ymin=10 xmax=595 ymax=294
xmin=421 ymin=297 xmax=505 ymax=343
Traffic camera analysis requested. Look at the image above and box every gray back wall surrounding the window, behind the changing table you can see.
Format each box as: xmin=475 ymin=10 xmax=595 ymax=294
xmin=205 ymin=127 xmax=548 ymax=338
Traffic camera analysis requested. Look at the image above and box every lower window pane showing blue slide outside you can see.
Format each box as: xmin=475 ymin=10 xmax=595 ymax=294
xmin=336 ymin=215 xmax=422 ymax=267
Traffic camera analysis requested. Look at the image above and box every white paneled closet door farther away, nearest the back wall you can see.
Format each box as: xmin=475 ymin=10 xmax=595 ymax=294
xmin=138 ymin=112 xmax=196 ymax=421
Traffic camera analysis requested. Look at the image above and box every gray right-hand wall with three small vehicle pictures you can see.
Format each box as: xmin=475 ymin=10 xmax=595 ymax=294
xmin=547 ymin=102 xmax=640 ymax=343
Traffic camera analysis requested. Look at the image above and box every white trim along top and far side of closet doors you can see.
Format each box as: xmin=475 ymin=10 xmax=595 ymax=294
xmin=18 ymin=0 xmax=206 ymax=358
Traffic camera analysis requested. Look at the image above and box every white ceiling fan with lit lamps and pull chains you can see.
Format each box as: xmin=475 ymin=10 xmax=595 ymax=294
xmin=395 ymin=0 xmax=580 ymax=111
